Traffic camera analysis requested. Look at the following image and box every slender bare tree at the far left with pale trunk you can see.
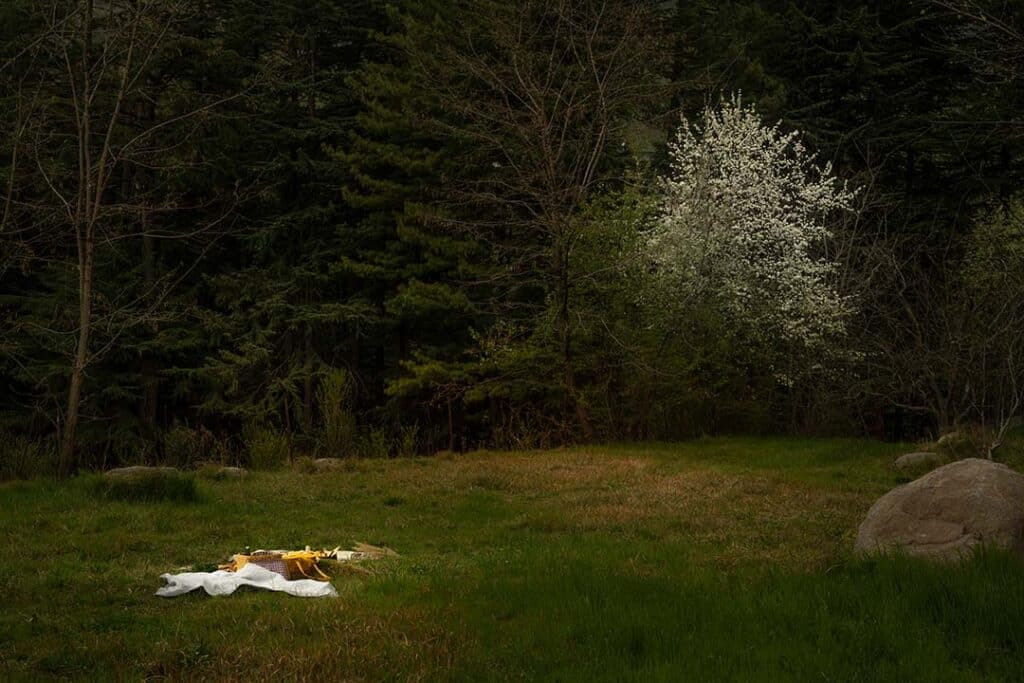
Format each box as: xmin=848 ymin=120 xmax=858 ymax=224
xmin=3 ymin=0 xmax=246 ymax=476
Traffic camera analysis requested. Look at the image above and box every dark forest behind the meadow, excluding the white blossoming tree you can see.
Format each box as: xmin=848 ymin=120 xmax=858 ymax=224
xmin=0 ymin=0 xmax=1024 ymax=472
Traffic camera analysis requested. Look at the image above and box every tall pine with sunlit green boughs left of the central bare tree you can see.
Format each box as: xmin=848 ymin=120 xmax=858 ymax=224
xmin=336 ymin=0 xmax=481 ymax=454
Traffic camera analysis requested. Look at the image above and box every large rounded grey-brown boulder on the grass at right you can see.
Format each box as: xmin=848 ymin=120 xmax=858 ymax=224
xmin=855 ymin=458 xmax=1024 ymax=559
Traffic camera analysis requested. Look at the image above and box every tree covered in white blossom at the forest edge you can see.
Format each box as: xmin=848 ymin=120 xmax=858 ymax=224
xmin=646 ymin=95 xmax=855 ymax=348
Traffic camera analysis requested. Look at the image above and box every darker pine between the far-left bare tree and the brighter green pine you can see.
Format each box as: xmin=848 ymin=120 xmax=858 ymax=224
xmin=185 ymin=0 xmax=387 ymax=444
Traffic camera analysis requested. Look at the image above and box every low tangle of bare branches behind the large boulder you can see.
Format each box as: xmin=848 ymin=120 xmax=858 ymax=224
xmin=865 ymin=200 xmax=1024 ymax=456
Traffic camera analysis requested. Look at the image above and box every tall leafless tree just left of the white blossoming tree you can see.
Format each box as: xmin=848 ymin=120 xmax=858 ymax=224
xmin=411 ymin=0 xmax=668 ymax=439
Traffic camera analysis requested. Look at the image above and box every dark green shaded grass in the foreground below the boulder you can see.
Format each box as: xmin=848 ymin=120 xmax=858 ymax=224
xmin=450 ymin=540 xmax=1024 ymax=681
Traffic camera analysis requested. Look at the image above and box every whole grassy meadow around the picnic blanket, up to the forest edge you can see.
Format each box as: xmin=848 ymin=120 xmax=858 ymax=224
xmin=0 ymin=438 xmax=1024 ymax=681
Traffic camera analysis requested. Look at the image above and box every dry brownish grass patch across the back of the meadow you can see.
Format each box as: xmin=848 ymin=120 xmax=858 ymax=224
xmin=305 ymin=450 xmax=876 ymax=568
